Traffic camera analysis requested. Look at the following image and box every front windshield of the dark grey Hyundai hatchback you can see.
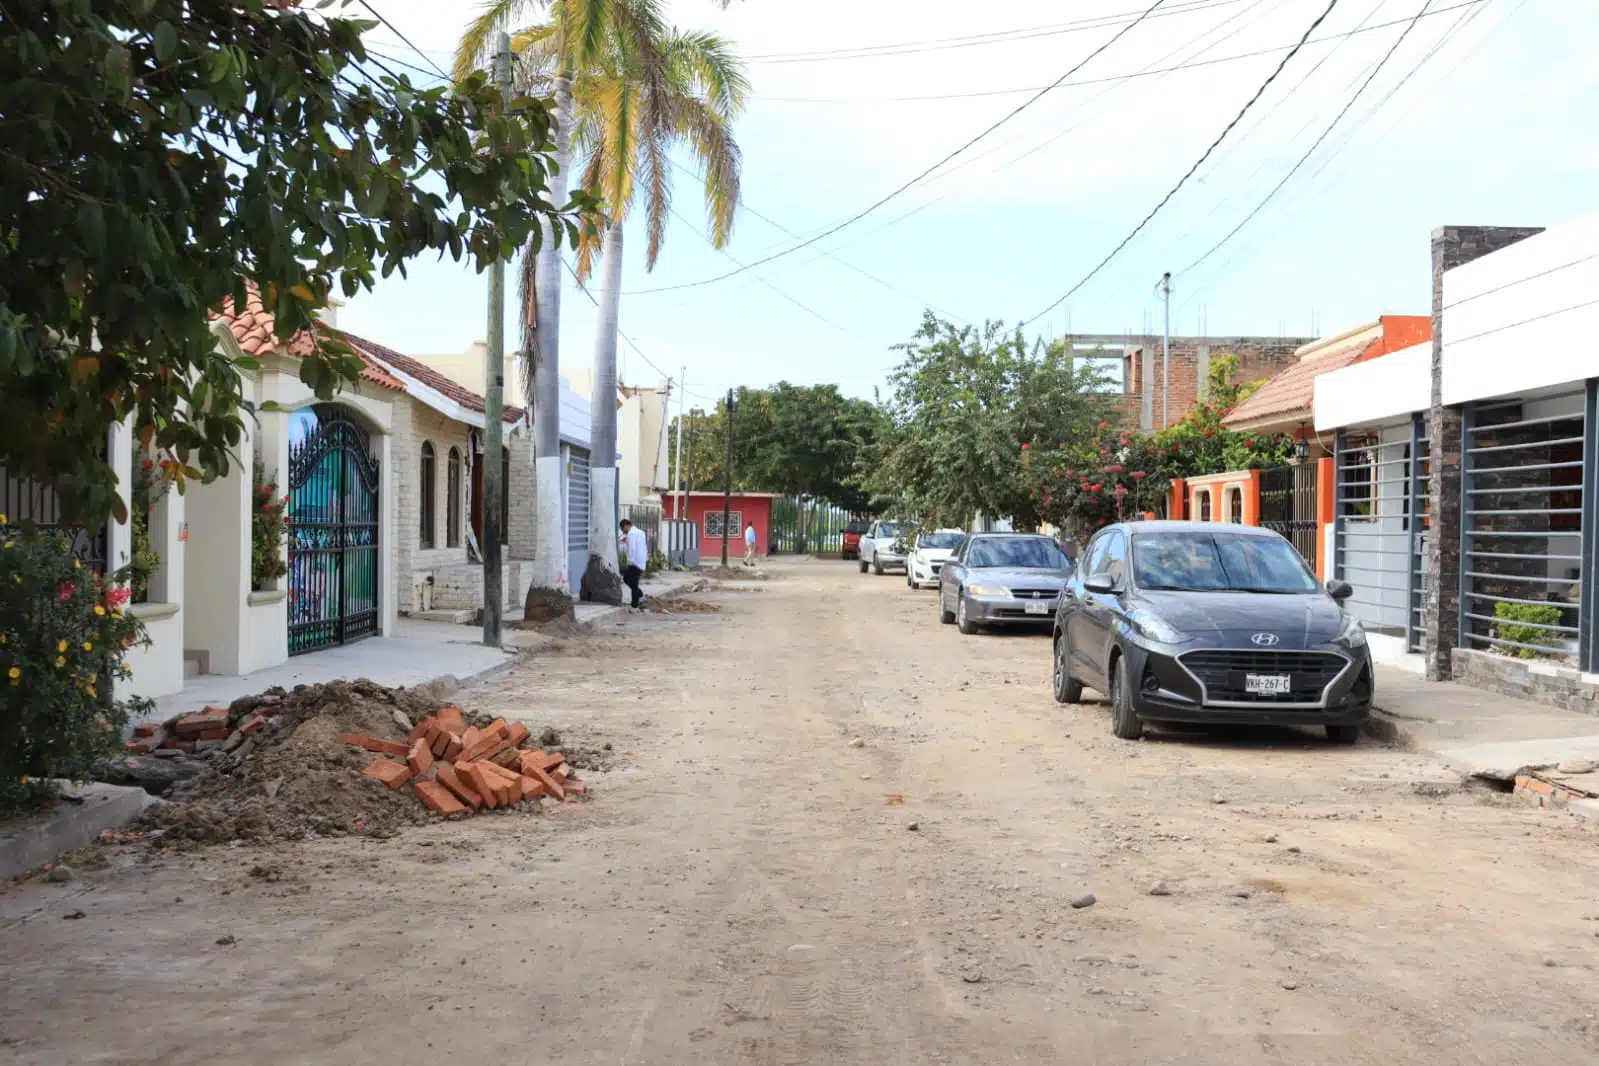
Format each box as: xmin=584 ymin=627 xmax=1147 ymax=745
xmin=1132 ymin=532 xmax=1316 ymax=593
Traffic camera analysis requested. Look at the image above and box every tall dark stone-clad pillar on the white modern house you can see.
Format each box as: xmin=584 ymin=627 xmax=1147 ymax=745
xmin=1422 ymin=225 xmax=1543 ymax=681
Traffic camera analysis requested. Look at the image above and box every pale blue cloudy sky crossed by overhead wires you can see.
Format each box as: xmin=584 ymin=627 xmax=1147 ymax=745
xmin=339 ymin=0 xmax=1599 ymax=406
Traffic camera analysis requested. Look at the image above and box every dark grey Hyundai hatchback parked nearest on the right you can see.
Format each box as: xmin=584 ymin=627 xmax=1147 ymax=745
xmin=1054 ymin=521 xmax=1375 ymax=743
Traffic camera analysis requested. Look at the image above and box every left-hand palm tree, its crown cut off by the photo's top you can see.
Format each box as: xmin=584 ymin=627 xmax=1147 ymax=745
xmin=456 ymin=0 xmax=731 ymax=620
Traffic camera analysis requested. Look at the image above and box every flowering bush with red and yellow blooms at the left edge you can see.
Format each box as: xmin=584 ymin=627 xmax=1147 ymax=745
xmin=0 ymin=515 xmax=149 ymax=810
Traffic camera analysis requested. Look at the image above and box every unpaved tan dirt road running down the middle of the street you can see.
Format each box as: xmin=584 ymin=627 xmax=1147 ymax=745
xmin=9 ymin=563 xmax=1599 ymax=1066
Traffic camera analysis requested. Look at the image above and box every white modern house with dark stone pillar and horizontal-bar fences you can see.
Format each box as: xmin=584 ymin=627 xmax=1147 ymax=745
xmin=1314 ymin=214 xmax=1599 ymax=713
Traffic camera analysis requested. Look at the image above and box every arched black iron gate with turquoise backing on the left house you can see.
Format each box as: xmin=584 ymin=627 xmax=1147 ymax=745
xmin=288 ymin=404 xmax=379 ymax=655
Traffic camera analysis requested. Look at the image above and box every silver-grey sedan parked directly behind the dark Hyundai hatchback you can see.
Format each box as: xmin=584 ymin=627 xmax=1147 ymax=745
xmin=939 ymin=534 xmax=1071 ymax=633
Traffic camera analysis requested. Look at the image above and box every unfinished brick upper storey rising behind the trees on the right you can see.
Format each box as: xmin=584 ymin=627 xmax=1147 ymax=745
xmin=1067 ymin=334 xmax=1314 ymax=432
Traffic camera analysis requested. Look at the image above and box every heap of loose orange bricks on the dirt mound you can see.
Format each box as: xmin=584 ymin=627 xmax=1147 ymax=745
xmin=339 ymin=706 xmax=587 ymax=817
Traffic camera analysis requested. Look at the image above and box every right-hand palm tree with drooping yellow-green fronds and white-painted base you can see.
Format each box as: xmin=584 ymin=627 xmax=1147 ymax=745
xmin=512 ymin=0 xmax=748 ymax=603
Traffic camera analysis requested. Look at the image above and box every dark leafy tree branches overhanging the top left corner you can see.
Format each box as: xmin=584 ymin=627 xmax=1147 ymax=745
xmin=0 ymin=0 xmax=584 ymax=523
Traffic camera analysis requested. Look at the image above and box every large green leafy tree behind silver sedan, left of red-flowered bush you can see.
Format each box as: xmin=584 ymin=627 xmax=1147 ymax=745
xmin=865 ymin=312 xmax=1110 ymax=529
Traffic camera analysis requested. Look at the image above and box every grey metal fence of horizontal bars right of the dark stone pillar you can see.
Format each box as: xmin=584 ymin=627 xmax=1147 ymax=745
xmin=1460 ymin=382 xmax=1596 ymax=670
